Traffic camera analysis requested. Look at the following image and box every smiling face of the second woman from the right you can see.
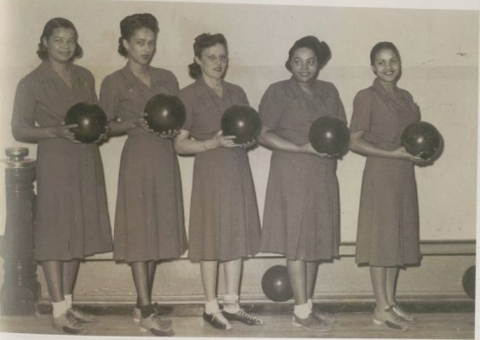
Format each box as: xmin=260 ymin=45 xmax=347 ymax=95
xmin=290 ymin=47 xmax=319 ymax=84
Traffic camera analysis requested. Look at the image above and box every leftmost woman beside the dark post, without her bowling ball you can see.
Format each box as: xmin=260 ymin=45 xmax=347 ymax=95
xmin=12 ymin=18 xmax=112 ymax=334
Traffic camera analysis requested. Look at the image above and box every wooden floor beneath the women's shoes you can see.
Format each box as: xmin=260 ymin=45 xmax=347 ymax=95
xmin=0 ymin=313 xmax=475 ymax=339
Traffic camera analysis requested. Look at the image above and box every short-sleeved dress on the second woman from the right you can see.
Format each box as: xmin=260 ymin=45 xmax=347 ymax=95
xmin=259 ymin=78 xmax=346 ymax=261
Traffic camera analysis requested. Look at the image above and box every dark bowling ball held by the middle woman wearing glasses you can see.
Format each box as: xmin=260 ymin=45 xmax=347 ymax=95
xmin=221 ymin=105 xmax=262 ymax=144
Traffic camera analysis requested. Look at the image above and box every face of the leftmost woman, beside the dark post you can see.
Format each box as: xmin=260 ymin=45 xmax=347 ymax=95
xmin=42 ymin=27 xmax=77 ymax=64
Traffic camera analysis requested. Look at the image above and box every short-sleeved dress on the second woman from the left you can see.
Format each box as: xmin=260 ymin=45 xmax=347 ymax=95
xmin=100 ymin=66 xmax=187 ymax=262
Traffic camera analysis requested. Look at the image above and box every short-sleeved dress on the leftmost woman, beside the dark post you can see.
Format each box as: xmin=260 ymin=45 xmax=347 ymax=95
xmin=11 ymin=61 xmax=112 ymax=261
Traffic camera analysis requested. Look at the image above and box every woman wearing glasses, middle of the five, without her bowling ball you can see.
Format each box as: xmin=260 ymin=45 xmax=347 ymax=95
xmin=174 ymin=34 xmax=263 ymax=330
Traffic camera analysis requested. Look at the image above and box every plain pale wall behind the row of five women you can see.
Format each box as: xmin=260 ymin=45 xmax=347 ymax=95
xmin=0 ymin=0 xmax=479 ymax=257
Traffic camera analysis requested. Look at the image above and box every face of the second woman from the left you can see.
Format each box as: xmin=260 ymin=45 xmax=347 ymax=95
xmin=123 ymin=27 xmax=157 ymax=65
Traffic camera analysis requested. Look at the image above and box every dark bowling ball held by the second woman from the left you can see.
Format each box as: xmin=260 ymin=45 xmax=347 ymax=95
xmin=145 ymin=94 xmax=187 ymax=133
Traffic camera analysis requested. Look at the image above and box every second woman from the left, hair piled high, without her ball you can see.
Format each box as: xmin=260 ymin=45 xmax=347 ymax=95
xmin=100 ymin=13 xmax=187 ymax=336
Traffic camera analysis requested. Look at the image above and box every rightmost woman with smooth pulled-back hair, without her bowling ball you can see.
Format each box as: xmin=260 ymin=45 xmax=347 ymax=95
xmin=350 ymin=42 xmax=421 ymax=331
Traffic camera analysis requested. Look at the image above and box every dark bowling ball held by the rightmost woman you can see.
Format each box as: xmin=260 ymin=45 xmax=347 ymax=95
xmin=401 ymin=121 xmax=441 ymax=160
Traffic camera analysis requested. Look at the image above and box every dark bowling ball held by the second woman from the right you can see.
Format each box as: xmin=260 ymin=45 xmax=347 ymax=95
xmin=308 ymin=116 xmax=350 ymax=157
